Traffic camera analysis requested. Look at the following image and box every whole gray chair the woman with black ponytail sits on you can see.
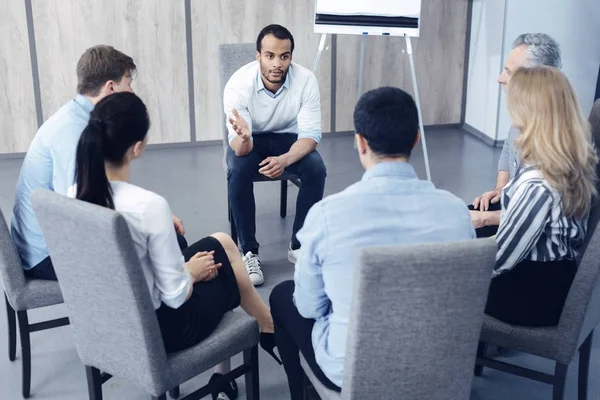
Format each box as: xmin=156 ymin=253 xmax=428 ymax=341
xmin=33 ymin=190 xmax=259 ymax=400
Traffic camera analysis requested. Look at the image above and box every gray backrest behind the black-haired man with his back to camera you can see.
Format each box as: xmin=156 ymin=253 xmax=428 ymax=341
xmin=342 ymin=238 xmax=496 ymax=400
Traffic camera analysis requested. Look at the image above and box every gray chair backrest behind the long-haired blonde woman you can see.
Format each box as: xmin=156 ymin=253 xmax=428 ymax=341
xmin=557 ymin=201 xmax=600 ymax=360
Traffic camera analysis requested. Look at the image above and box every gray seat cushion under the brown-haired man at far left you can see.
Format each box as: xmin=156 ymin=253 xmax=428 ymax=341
xmin=9 ymin=279 xmax=63 ymax=311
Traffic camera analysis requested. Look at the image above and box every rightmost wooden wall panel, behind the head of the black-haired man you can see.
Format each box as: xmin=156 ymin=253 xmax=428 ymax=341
xmin=336 ymin=0 xmax=468 ymax=131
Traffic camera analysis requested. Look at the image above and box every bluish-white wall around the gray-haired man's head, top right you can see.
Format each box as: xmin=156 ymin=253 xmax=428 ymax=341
xmin=498 ymin=0 xmax=600 ymax=139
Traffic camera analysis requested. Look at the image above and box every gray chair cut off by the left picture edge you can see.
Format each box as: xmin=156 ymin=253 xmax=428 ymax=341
xmin=0 ymin=205 xmax=69 ymax=398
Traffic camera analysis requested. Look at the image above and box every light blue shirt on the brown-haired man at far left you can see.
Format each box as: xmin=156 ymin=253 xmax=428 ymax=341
xmin=11 ymin=95 xmax=94 ymax=269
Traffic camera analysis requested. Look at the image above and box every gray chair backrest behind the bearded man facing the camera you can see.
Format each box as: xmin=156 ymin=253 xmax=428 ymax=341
xmin=219 ymin=43 xmax=256 ymax=170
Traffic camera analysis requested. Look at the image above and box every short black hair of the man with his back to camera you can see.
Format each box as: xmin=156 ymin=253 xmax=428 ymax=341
xmin=354 ymin=87 xmax=419 ymax=158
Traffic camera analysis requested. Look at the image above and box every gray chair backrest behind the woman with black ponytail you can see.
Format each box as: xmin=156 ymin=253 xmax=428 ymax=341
xmin=32 ymin=189 xmax=172 ymax=392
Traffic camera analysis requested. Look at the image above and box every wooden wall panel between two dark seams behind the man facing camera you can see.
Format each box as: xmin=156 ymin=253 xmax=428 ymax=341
xmin=192 ymin=0 xmax=331 ymax=140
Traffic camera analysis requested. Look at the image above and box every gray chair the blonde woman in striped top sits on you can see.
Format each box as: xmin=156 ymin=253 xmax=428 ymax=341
xmin=475 ymin=203 xmax=600 ymax=400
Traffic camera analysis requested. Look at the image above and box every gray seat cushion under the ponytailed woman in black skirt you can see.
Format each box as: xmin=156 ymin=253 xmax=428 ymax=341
xmin=162 ymin=311 xmax=259 ymax=392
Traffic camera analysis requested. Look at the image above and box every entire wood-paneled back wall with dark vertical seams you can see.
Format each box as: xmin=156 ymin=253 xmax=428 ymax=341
xmin=0 ymin=0 xmax=468 ymax=153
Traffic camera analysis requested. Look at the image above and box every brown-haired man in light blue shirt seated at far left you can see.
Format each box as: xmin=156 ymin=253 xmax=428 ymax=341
xmin=11 ymin=45 xmax=141 ymax=280
